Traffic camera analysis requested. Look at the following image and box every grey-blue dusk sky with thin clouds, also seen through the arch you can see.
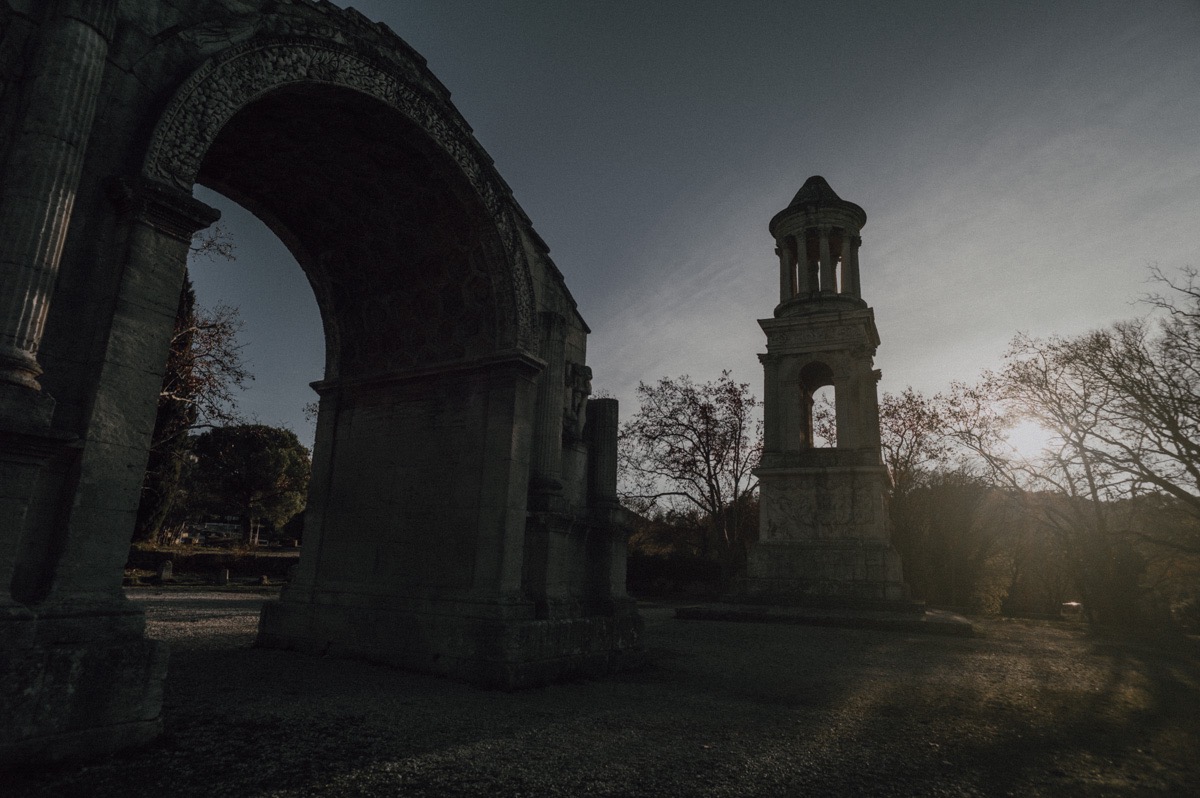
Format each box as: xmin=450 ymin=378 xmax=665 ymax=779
xmin=193 ymin=0 xmax=1200 ymax=442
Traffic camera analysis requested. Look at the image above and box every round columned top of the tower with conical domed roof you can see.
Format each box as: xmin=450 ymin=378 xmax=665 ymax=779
xmin=769 ymin=175 xmax=866 ymax=317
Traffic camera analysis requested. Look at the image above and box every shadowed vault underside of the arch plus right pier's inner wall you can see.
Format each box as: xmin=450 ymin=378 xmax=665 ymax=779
xmin=182 ymin=83 xmax=510 ymax=578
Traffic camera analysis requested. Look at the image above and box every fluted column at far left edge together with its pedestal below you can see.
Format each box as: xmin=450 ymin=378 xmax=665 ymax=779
xmin=0 ymin=0 xmax=116 ymax=650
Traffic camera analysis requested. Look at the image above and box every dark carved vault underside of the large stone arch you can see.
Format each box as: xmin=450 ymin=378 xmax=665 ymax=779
xmin=197 ymin=84 xmax=505 ymax=380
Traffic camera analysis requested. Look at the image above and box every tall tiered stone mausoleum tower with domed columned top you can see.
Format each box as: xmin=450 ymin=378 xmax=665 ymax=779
xmin=744 ymin=176 xmax=907 ymax=604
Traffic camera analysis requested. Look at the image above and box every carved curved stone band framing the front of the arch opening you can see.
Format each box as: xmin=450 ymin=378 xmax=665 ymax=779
xmin=142 ymin=37 xmax=536 ymax=350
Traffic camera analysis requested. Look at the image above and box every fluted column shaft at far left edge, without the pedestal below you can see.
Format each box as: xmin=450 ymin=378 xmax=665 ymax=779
xmin=0 ymin=0 xmax=116 ymax=400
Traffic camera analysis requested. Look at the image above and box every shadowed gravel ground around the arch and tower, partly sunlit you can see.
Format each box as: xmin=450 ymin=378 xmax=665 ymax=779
xmin=0 ymin=590 xmax=1200 ymax=798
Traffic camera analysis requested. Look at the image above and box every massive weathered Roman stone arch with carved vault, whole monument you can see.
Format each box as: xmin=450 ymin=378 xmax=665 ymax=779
xmin=0 ymin=0 xmax=640 ymax=762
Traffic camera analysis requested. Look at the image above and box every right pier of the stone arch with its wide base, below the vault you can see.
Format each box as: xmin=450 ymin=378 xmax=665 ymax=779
xmin=258 ymin=364 xmax=642 ymax=689
